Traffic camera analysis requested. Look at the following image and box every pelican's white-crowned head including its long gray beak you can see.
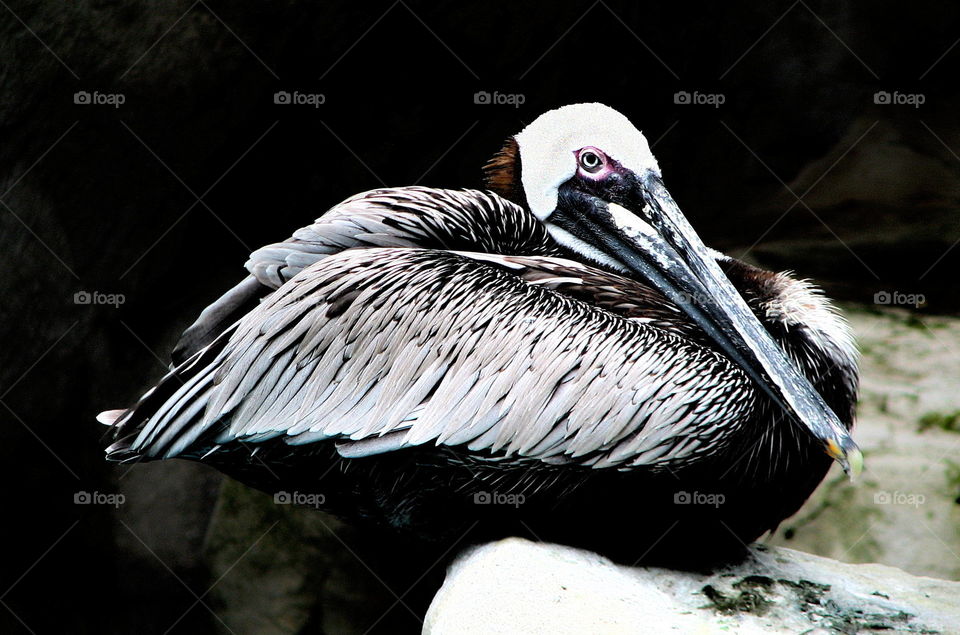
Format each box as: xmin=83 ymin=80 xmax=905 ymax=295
xmin=485 ymin=104 xmax=863 ymax=476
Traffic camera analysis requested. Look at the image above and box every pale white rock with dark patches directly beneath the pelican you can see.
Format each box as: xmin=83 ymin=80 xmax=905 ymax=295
xmin=423 ymin=538 xmax=960 ymax=635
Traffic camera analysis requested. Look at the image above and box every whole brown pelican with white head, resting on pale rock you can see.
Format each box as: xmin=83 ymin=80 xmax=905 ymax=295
xmin=98 ymin=104 xmax=862 ymax=561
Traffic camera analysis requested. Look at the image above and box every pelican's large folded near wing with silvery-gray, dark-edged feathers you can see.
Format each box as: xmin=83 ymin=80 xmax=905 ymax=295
xmin=133 ymin=248 xmax=755 ymax=467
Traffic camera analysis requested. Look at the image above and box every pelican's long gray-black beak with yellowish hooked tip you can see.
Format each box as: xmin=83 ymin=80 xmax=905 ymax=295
xmin=548 ymin=174 xmax=863 ymax=478
